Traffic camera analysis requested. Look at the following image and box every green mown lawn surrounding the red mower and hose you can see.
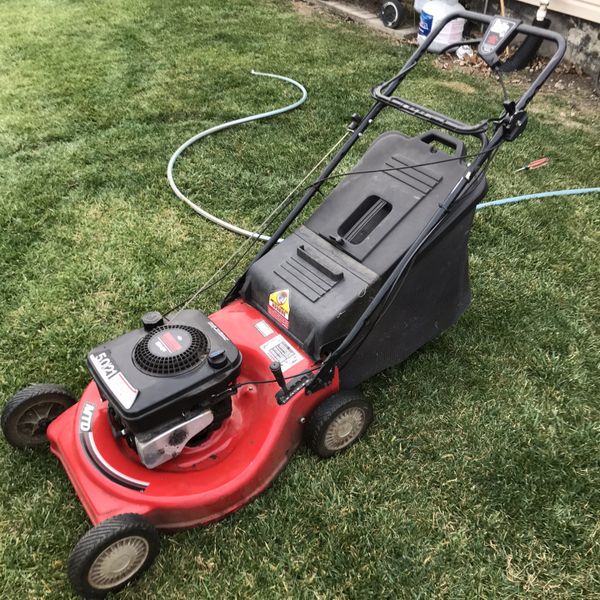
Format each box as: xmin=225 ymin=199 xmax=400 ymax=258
xmin=0 ymin=0 xmax=600 ymax=599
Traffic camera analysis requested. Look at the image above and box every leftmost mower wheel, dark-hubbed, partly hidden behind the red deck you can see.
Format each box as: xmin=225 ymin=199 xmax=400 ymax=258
xmin=0 ymin=383 xmax=76 ymax=448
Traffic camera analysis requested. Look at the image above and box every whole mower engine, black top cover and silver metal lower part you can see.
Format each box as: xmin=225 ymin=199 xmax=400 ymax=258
xmin=87 ymin=310 xmax=242 ymax=469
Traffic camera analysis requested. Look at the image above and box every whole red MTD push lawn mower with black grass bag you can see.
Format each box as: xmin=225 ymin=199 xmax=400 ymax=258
xmin=1 ymin=11 xmax=565 ymax=597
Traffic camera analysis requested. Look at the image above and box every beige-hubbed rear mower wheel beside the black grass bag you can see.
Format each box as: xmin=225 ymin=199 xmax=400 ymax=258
xmin=306 ymin=390 xmax=373 ymax=458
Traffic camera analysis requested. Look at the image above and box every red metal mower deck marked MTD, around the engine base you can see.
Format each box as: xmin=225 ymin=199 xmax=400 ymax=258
xmin=48 ymin=300 xmax=339 ymax=529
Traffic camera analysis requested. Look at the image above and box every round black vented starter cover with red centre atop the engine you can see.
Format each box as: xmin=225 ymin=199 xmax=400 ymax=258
xmin=133 ymin=325 xmax=210 ymax=377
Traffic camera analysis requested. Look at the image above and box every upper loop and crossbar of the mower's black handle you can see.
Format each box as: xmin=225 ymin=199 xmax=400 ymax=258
xmin=371 ymin=11 xmax=566 ymax=138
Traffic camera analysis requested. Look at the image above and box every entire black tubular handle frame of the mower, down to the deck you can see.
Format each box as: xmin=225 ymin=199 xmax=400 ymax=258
xmin=222 ymin=11 xmax=566 ymax=392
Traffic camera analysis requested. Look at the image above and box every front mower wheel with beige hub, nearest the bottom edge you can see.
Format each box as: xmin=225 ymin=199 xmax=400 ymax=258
xmin=69 ymin=513 xmax=160 ymax=598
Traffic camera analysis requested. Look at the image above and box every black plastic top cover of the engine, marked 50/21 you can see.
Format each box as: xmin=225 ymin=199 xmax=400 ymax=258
xmin=87 ymin=310 xmax=242 ymax=434
